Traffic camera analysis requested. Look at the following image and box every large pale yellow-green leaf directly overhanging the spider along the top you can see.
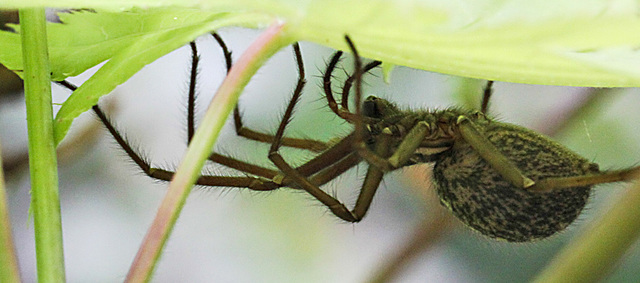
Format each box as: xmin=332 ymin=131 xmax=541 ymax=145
xmin=4 ymin=0 xmax=640 ymax=87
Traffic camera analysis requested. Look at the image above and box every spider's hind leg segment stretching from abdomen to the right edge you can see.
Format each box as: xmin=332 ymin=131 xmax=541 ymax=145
xmin=528 ymin=166 xmax=640 ymax=192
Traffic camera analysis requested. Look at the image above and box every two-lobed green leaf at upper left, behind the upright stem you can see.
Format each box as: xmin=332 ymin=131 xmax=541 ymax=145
xmin=0 ymin=8 xmax=266 ymax=143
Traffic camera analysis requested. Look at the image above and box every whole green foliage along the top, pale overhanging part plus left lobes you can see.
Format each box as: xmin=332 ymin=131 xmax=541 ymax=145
xmin=0 ymin=0 xmax=640 ymax=144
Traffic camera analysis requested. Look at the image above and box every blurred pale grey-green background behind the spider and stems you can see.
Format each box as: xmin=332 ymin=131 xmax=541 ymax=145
xmin=0 ymin=29 xmax=640 ymax=282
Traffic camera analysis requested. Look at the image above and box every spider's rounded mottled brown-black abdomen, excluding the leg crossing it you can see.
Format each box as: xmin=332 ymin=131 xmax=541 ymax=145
xmin=433 ymin=122 xmax=598 ymax=242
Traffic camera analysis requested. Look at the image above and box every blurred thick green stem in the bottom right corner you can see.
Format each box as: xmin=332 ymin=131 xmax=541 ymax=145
xmin=535 ymin=176 xmax=640 ymax=283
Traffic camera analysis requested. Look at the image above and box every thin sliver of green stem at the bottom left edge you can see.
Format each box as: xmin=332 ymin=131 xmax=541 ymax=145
xmin=0 ymin=146 xmax=21 ymax=283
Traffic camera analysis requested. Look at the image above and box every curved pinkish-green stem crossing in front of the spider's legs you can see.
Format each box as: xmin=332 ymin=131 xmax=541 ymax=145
xmin=126 ymin=22 xmax=291 ymax=282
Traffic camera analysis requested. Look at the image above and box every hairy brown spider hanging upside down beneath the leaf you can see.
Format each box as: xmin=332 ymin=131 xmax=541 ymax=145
xmin=60 ymin=33 xmax=640 ymax=242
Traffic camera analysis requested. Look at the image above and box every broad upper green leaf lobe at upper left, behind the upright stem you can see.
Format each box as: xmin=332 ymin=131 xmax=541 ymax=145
xmin=0 ymin=8 xmax=262 ymax=80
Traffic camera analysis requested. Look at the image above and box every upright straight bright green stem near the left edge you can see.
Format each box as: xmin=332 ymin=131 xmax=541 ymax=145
xmin=19 ymin=8 xmax=65 ymax=282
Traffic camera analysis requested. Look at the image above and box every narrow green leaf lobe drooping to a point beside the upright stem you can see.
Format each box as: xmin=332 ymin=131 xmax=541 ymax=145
xmin=55 ymin=10 xmax=268 ymax=143
